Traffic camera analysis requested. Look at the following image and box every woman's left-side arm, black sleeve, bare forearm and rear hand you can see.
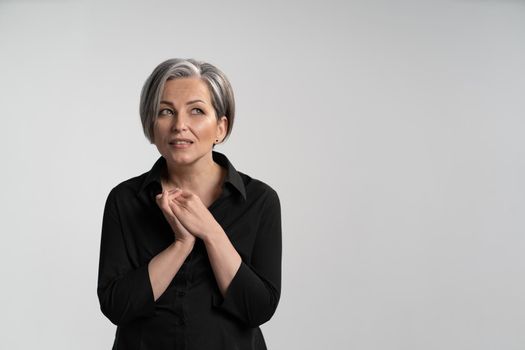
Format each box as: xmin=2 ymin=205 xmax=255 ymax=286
xmin=97 ymin=191 xmax=193 ymax=325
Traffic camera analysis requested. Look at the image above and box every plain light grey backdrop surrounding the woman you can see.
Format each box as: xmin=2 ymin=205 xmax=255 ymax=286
xmin=0 ymin=0 xmax=525 ymax=350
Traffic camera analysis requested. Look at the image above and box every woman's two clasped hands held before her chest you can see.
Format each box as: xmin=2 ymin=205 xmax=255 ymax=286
xmin=156 ymin=188 xmax=222 ymax=248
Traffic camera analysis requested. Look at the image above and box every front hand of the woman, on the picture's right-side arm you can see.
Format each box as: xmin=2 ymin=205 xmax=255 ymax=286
xmin=170 ymin=190 xmax=222 ymax=242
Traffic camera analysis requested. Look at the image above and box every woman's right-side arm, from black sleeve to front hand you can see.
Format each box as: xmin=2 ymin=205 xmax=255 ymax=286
xmin=171 ymin=189 xmax=282 ymax=327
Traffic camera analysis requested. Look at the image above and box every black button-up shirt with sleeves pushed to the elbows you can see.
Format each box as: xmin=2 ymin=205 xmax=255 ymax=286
xmin=97 ymin=152 xmax=281 ymax=350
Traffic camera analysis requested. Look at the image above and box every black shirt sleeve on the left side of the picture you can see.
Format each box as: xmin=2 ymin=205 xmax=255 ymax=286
xmin=97 ymin=190 xmax=155 ymax=325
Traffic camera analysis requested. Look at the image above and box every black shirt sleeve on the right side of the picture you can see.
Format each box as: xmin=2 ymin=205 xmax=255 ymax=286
xmin=213 ymin=190 xmax=282 ymax=327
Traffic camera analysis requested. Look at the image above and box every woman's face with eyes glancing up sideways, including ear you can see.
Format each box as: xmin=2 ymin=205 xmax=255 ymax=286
xmin=154 ymin=78 xmax=228 ymax=165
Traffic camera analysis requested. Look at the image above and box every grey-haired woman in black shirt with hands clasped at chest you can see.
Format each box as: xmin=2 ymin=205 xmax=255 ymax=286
xmin=97 ymin=59 xmax=281 ymax=350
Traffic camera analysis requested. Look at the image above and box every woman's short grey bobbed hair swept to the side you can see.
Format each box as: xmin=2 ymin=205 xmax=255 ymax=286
xmin=139 ymin=58 xmax=235 ymax=143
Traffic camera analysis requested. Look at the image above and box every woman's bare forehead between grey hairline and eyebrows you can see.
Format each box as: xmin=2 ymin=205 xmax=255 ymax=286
xmin=162 ymin=78 xmax=210 ymax=103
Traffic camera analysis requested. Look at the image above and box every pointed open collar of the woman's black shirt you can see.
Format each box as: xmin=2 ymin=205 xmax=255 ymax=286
xmin=138 ymin=151 xmax=246 ymax=200
